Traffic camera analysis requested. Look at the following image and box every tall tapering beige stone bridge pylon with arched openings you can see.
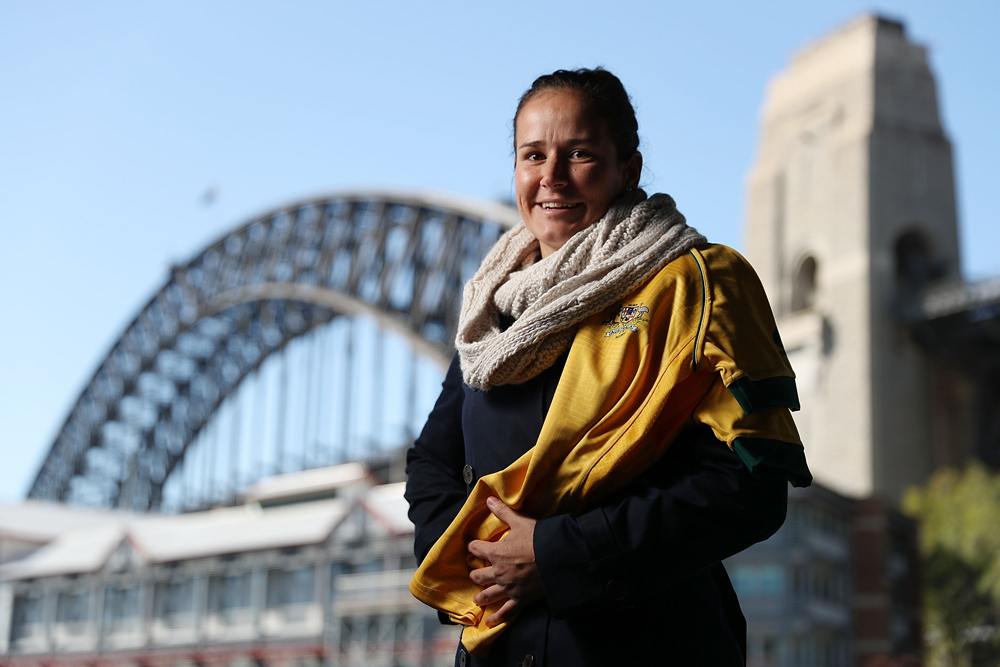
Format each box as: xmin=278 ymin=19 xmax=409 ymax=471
xmin=744 ymin=16 xmax=960 ymax=501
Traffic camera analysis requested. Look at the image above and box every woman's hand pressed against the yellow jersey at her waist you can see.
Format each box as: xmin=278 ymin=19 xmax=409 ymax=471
xmin=469 ymin=497 xmax=545 ymax=628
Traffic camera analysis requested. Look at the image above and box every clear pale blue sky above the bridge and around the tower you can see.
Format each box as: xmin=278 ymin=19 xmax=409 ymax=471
xmin=0 ymin=0 xmax=1000 ymax=500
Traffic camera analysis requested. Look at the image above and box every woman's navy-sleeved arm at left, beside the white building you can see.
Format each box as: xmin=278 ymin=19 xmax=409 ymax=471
xmin=405 ymin=355 xmax=466 ymax=561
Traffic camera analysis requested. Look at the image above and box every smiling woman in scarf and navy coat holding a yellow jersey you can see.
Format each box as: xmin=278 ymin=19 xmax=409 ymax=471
xmin=406 ymin=69 xmax=811 ymax=667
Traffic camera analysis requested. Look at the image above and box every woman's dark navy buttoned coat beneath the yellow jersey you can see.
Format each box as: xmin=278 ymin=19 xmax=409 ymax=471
xmin=406 ymin=356 xmax=787 ymax=667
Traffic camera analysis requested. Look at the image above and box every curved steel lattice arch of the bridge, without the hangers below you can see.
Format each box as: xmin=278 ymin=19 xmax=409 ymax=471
xmin=28 ymin=190 xmax=519 ymax=511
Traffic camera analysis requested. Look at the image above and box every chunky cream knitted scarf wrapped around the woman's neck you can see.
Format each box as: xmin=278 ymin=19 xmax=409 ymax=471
xmin=455 ymin=190 xmax=706 ymax=389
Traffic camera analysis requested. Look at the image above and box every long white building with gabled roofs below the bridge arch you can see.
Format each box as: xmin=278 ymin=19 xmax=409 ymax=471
xmin=0 ymin=464 xmax=458 ymax=667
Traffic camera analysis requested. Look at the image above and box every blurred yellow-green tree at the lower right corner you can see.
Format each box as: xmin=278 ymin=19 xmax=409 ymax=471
xmin=903 ymin=463 xmax=1000 ymax=667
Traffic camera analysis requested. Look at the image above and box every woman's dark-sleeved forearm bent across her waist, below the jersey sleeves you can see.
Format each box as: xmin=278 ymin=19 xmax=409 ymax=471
xmin=533 ymin=427 xmax=788 ymax=616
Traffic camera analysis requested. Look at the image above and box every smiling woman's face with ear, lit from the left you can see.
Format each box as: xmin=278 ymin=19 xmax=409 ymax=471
xmin=514 ymin=89 xmax=642 ymax=257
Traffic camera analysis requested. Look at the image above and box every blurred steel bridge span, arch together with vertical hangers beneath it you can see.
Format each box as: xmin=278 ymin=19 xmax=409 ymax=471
xmin=28 ymin=191 xmax=519 ymax=512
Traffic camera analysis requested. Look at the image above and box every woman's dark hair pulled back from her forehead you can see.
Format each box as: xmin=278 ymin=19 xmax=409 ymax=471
xmin=514 ymin=67 xmax=639 ymax=162
